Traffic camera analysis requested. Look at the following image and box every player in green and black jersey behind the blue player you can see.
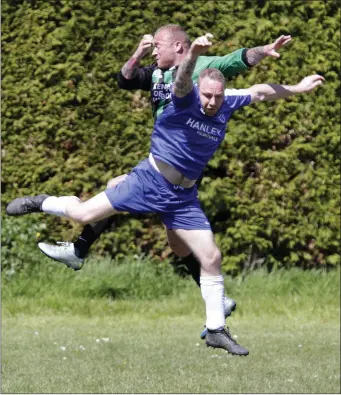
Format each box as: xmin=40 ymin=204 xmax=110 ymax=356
xmin=33 ymin=24 xmax=291 ymax=336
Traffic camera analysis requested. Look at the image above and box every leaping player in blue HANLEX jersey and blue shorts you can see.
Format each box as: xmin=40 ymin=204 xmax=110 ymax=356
xmin=6 ymin=33 xmax=324 ymax=355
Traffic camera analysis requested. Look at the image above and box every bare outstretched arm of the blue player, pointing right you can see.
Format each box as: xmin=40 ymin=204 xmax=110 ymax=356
xmin=247 ymin=74 xmax=324 ymax=103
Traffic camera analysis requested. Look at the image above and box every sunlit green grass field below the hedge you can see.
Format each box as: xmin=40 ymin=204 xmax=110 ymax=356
xmin=1 ymin=263 xmax=340 ymax=393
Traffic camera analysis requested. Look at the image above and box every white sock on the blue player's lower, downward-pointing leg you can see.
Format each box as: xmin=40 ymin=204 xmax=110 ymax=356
xmin=200 ymin=275 xmax=225 ymax=329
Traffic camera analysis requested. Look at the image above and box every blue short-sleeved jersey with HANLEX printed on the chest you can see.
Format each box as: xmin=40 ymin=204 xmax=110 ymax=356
xmin=151 ymin=86 xmax=251 ymax=180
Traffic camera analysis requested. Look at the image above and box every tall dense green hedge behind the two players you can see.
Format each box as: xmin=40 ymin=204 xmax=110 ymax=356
xmin=2 ymin=0 xmax=340 ymax=272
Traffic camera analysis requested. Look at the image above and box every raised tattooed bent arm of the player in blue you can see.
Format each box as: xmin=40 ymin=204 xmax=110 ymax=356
xmin=173 ymin=33 xmax=213 ymax=97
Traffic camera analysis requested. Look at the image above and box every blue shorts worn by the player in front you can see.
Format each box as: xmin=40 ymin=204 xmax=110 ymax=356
xmin=105 ymin=159 xmax=211 ymax=230
